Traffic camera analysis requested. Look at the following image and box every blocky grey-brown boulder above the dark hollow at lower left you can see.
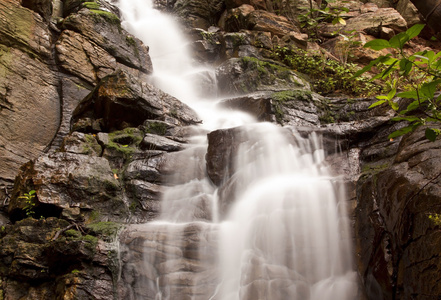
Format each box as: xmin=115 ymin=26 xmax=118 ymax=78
xmin=9 ymin=152 xmax=128 ymax=220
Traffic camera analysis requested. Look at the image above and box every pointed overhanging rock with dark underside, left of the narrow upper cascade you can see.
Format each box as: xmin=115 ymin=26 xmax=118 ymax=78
xmin=73 ymin=70 xmax=198 ymax=131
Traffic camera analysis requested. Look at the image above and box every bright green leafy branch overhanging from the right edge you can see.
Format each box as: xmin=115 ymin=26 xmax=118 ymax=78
xmin=354 ymin=24 xmax=441 ymax=141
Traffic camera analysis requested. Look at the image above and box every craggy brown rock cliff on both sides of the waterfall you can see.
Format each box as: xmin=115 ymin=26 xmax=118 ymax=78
xmin=0 ymin=0 xmax=441 ymax=299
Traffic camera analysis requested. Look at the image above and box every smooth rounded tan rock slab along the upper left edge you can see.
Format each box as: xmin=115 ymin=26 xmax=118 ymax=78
xmin=0 ymin=0 xmax=61 ymax=185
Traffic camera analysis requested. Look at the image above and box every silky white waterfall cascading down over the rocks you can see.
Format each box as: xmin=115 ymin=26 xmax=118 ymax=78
xmin=114 ymin=0 xmax=357 ymax=300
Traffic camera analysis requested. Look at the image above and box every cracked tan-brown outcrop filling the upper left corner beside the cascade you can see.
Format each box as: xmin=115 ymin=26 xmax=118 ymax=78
xmin=0 ymin=0 xmax=152 ymax=189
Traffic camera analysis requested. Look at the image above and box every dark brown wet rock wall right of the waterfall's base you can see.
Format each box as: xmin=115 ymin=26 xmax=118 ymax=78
xmin=356 ymin=128 xmax=441 ymax=298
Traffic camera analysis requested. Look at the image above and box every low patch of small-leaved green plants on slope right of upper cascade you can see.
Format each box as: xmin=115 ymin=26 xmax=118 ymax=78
xmin=274 ymin=47 xmax=381 ymax=96
